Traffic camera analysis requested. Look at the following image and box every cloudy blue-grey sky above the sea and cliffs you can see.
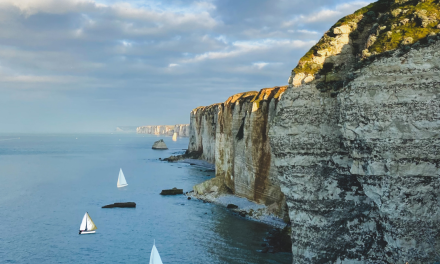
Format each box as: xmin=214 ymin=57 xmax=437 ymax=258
xmin=0 ymin=0 xmax=374 ymax=133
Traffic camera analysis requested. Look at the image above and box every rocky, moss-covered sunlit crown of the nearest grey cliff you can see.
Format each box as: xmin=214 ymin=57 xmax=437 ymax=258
xmin=289 ymin=0 xmax=440 ymax=86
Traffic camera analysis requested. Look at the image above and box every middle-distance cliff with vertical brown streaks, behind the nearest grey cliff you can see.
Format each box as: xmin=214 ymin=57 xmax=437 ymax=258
xmin=188 ymin=87 xmax=287 ymax=217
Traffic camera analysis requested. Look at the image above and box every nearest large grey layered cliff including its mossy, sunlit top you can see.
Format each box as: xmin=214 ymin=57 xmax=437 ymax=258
xmin=269 ymin=0 xmax=440 ymax=264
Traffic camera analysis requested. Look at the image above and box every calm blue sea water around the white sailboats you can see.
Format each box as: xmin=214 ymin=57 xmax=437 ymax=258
xmin=0 ymin=134 xmax=292 ymax=264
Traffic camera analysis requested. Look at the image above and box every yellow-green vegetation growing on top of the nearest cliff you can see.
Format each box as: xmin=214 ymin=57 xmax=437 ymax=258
xmin=293 ymin=0 xmax=440 ymax=74
